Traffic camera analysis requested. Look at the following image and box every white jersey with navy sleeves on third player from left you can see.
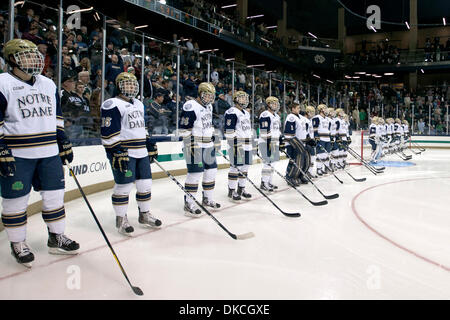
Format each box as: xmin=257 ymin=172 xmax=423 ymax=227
xmin=179 ymin=100 xmax=214 ymax=148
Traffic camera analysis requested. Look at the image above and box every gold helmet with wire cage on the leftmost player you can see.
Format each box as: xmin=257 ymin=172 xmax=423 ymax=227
xmin=3 ymin=39 xmax=45 ymax=76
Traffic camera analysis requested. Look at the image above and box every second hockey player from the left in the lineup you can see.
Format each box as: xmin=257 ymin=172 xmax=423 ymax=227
xmin=100 ymin=72 xmax=161 ymax=236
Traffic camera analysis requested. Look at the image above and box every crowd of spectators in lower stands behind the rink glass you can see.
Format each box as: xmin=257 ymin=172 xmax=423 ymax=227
xmin=0 ymin=0 xmax=450 ymax=145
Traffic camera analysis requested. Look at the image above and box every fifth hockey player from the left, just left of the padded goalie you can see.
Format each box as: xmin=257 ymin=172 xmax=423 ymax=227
xmin=258 ymin=96 xmax=282 ymax=191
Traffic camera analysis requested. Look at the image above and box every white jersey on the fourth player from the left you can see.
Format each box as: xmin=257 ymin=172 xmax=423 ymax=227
xmin=224 ymin=107 xmax=253 ymax=151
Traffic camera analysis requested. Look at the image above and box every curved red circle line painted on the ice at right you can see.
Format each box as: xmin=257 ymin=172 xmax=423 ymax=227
xmin=352 ymin=177 xmax=450 ymax=271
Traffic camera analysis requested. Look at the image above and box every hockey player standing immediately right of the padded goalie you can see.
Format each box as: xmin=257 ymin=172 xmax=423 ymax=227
xmin=312 ymin=104 xmax=331 ymax=176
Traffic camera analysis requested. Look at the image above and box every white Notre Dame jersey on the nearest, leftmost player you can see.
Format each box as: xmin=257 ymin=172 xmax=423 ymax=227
xmin=0 ymin=73 xmax=64 ymax=159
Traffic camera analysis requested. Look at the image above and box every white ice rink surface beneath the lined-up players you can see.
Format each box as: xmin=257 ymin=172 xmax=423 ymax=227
xmin=0 ymin=149 xmax=450 ymax=300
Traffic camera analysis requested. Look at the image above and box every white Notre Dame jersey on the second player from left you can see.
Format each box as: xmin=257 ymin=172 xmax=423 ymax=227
xmin=100 ymin=98 xmax=148 ymax=158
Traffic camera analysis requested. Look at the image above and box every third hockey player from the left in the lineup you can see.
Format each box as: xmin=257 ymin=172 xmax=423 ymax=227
xmin=179 ymin=82 xmax=220 ymax=217
